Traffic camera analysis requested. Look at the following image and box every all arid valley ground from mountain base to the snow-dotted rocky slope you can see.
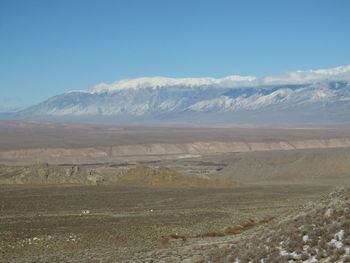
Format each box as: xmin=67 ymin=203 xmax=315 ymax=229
xmin=0 ymin=121 xmax=350 ymax=262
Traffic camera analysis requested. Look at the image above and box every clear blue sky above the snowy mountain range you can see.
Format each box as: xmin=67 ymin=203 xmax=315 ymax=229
xmin=0 ymin=0 xmax=350 ymax=107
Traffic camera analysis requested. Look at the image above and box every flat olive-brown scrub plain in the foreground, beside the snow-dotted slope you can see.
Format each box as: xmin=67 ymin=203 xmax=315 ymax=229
xmin=0 ymin=185 xmax=340 ymax=262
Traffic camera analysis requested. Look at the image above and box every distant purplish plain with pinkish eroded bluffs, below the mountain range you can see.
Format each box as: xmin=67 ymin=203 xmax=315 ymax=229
xmin=0 ymin=121 xmax=350 ymax=164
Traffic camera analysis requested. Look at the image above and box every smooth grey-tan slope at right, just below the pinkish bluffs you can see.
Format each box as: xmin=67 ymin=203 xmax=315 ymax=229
xmin=219 ymin=148 xmax=350 ymax=183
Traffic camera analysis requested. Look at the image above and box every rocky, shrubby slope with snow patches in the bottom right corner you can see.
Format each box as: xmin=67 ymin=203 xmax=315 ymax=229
xmin=201 ymin=186 xmax=350 ymax=263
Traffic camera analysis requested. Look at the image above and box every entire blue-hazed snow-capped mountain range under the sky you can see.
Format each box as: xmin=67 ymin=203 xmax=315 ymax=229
xmin=17 ymin=66 xmax=350 ymax=122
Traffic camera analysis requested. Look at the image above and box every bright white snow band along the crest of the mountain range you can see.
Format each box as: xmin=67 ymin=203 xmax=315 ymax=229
xmin=86 ymin=65 xmax=350 ymax=93
